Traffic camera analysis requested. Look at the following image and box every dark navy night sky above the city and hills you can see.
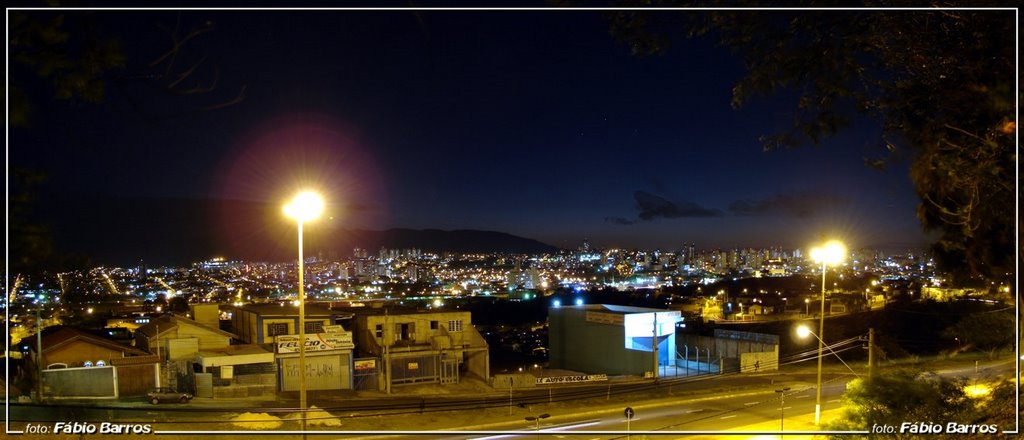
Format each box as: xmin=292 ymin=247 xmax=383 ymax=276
xmin=8 ymin=10 xmax=937 ymax=264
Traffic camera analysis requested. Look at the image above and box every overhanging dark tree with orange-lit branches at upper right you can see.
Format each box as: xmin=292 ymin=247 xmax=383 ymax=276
xmin=609 ymin=1 xmax=1017 ymax=281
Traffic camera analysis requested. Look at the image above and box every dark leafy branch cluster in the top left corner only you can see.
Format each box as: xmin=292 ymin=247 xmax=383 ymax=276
xmin=7 ymin=9 xmax=247 ymax=127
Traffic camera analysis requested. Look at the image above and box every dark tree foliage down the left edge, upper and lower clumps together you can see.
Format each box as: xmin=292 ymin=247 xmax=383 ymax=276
xmin=6 ymin=7 xmax=246 ymax=273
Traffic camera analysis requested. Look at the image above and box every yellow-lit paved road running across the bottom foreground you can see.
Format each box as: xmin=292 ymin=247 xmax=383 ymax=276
xmin=10 ymin=359 xmax=1015 ymax=439
